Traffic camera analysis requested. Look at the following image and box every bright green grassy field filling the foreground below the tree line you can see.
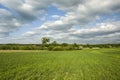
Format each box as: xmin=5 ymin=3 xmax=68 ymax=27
xmin=0 ymin=48 xmax=120 ymax=80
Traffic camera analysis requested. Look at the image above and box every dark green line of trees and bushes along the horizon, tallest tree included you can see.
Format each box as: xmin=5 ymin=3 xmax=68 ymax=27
xmin=0 ymin=37 xmax=120 ymax=51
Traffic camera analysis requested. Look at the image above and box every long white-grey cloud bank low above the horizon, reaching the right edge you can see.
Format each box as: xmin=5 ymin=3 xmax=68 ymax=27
xmin=24 ymin=21 xmax=120 ymax=43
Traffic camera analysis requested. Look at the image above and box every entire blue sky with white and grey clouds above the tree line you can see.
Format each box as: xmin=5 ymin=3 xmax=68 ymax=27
xmin=0 ymin=0 xmax=120 ymax=44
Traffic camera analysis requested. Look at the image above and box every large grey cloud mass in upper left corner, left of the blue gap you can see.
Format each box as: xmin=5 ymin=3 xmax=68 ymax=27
xmin=0 ymin=0 xmax=47 ymax=37
